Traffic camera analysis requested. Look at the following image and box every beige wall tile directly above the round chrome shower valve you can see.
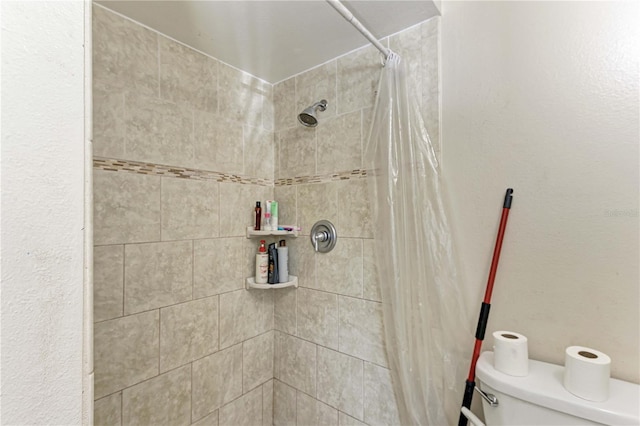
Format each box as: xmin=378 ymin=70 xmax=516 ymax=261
xmin=297 ymin=182 xmax=341 ymax=238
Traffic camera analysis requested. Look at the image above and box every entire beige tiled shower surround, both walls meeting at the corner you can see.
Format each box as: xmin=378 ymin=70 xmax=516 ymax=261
xmin=93 ymin=5 xmax=439 ymax=425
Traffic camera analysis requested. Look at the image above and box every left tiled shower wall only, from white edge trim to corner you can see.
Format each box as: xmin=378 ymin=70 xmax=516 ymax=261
xmin=93 ymin=4 xmax=274 ymax=425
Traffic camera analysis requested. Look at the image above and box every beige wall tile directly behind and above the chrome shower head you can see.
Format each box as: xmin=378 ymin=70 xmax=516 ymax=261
xmin=295 ymin=60 xmax=337 ymax=122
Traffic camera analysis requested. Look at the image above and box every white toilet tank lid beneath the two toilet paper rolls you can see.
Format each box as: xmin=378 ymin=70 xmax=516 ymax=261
xmin=476 ymin=351 xmax=640 ymax=425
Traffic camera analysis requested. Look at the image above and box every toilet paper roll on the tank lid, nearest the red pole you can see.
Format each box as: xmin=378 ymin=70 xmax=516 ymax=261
xmin=493 ymin=331 xmax=529 ymax=376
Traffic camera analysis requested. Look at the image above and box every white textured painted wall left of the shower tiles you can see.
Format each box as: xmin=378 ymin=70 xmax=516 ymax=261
xmin=1 ymin=1 xmax=85 ymax=425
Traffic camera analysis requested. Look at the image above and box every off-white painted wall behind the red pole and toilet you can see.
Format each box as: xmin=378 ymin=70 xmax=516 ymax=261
xmin=442 ymin=1 xmax=640 ymax=382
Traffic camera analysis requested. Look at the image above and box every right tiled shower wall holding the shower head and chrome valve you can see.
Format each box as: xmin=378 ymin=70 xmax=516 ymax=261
xmin=273 ymin=19 xmax=439 ymax=426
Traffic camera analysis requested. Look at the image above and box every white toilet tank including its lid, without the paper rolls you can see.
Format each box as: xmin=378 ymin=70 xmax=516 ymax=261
xmin=476 ymin=352 xmax=640 ymax=426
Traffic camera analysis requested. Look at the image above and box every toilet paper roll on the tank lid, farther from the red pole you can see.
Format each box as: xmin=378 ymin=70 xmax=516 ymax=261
xmin=564 ymin=346 xmax=611 ymax=402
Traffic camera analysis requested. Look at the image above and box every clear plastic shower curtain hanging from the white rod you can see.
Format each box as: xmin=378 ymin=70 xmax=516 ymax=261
xmin=366 ymin=53 xmax=473 ymax=426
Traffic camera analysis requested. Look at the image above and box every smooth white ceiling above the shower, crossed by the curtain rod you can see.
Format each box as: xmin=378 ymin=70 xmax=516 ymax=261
xmin=96 ymin=0 xmax=439 ymax=83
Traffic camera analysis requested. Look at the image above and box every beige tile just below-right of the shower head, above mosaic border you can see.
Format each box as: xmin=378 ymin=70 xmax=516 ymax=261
xmin=316 ymin=110 xmax=362 ymax=174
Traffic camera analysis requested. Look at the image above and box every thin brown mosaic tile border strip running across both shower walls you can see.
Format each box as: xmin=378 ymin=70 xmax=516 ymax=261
xmin=93 ymin=157 xmax=372 ymax=186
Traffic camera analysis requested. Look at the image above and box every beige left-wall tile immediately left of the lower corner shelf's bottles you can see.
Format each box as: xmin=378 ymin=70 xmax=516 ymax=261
xmin=193 ymin=237 xmax=246 ymax=298
